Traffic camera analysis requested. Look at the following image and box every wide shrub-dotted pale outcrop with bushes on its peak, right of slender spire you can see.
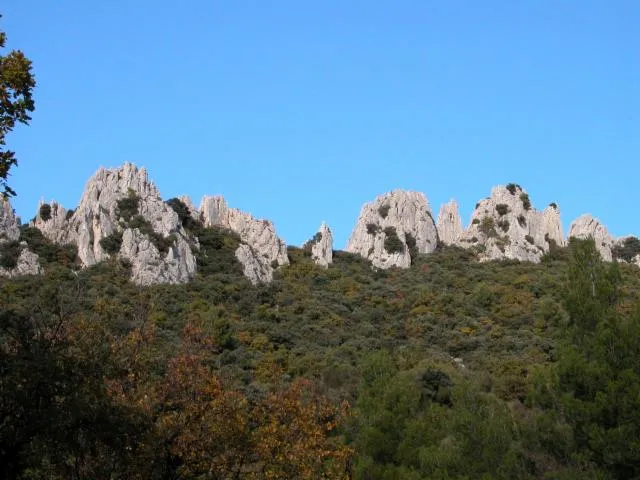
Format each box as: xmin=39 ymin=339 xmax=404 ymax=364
xmin=458 ymin=184 xmax=564 ymax=262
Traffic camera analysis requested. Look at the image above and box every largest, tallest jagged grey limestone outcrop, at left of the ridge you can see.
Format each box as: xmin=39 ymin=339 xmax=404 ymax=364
xmin=33 ymin=163 xmax=196 ymax=285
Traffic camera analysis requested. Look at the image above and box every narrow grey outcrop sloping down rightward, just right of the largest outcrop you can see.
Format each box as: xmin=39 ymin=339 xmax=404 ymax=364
xmin=200 ymin=195 xmax=289 ymax=284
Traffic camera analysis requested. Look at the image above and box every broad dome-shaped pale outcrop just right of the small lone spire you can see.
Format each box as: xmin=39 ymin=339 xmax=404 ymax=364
xmin=347 ymin=190 xmax=438 ymax=268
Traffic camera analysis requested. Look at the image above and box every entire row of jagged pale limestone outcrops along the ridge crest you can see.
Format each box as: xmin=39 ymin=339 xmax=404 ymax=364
xmin=0 ymin=163 xmax=640 ymax=285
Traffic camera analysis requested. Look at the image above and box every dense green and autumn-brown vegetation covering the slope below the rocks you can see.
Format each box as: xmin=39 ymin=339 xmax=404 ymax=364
xmin=0 ymin=230 xmax=640 ymax=479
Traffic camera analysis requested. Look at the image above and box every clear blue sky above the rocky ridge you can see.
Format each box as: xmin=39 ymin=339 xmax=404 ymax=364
xmin=0 ymin=0 xmax=640 ymax=248
